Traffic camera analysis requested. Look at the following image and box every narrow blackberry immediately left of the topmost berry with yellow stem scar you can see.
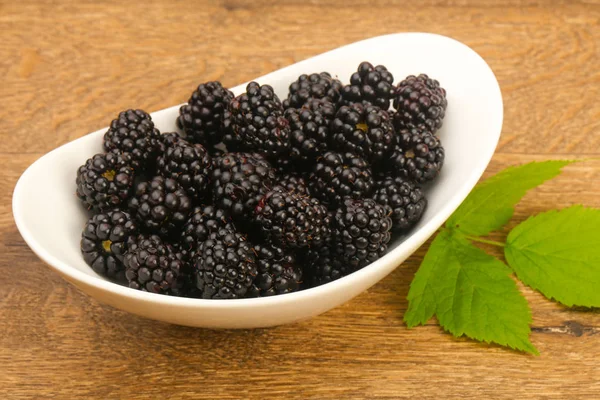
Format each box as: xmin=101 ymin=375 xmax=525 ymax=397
xmin=285 ymin=100 xmax=337 ymax=167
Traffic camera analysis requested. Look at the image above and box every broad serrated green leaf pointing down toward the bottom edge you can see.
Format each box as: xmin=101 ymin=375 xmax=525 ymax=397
xmin=404 ymin=229 xmax=538 ymax=354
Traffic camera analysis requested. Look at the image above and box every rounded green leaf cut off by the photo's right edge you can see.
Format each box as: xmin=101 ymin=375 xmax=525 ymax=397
xmin=504 ymin=206 xmax=600 ymax=307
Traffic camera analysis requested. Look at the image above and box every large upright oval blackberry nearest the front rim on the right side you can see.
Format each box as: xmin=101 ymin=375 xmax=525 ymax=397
xmin=333 ymin=199 xmax=392 ymax=269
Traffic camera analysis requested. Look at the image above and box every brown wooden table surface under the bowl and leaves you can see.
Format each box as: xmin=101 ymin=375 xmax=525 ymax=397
xmin=0 ymin=0 xmax=600 ymax=399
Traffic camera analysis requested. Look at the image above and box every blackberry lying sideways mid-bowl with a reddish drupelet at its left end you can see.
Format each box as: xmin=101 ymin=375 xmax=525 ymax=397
xmin=254 ymin=186 xmax=331 ymax=248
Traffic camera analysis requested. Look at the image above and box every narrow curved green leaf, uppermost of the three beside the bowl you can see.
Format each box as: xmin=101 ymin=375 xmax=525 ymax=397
xmin=446 ymin=160 xmax=574 ymax=236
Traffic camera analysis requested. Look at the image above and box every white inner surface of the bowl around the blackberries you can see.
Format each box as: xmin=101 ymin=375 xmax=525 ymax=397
xmin=13 ymin=33 xmax=502 ymax=316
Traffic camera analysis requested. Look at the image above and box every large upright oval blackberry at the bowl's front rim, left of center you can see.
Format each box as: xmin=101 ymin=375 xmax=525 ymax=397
xmin=195 ymin=228 xmax=257 ymax=299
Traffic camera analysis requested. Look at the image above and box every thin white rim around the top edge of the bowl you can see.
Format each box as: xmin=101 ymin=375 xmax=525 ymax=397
xmin=12 ymin=32 xmax=504 ymax=309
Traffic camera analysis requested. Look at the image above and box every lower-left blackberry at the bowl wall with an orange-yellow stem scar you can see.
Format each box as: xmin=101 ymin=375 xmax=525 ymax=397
xmin=81 ymin=210 xmax=137 ymax=281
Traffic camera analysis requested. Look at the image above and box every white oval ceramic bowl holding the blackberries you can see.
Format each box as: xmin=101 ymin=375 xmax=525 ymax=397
xmin=13 ymin=33 xmax=503 ymax=328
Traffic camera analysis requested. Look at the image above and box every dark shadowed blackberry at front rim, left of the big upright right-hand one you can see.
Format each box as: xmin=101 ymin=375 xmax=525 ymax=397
xmin=302 ymin=244 xmax=354 ymax=287
